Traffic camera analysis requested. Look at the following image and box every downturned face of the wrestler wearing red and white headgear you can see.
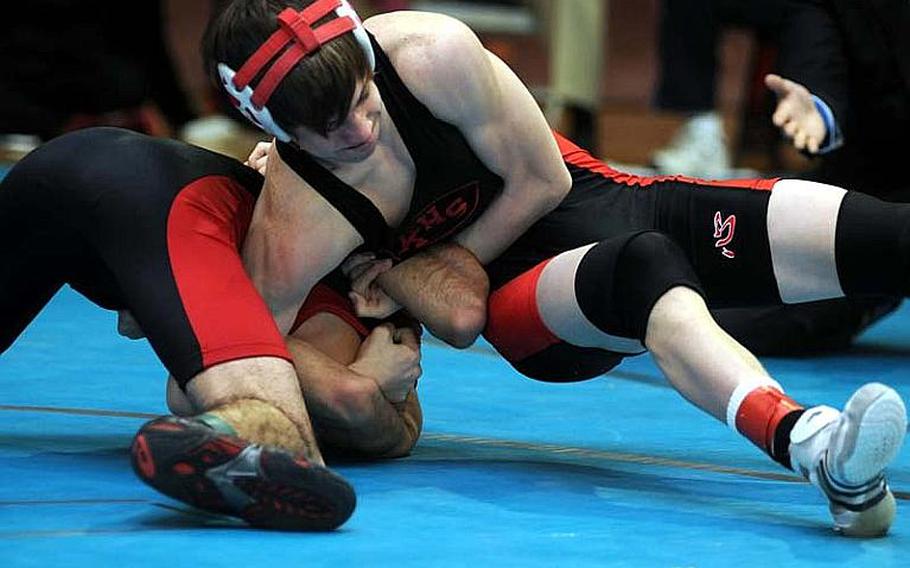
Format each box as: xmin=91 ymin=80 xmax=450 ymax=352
xmin=294 ymin=80 xmax=382 ymax=162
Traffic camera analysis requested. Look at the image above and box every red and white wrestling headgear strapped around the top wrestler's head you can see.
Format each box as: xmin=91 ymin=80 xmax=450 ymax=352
xmin=218 ymin=0 xmax=376 ymax=142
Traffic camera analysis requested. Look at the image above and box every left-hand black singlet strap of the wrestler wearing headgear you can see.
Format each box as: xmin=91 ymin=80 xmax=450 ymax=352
xmin=275 ymin=141 xmax=389 ymax=248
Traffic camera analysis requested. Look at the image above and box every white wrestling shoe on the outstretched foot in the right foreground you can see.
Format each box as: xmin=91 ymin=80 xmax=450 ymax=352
xmin=790 ymin=383 xmax=907 ymax=537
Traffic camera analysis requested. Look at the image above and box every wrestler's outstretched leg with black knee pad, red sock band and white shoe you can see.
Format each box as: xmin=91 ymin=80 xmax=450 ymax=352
xmin=488 ymin=227 xmax=906 ymax=536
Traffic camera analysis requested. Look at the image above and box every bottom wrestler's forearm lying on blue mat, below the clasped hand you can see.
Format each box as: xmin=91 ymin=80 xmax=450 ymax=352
xmin=287 ymin=338 xmax=422 ymax=457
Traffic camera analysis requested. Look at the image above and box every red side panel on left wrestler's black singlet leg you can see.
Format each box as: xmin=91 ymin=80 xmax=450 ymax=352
xmin=167 ymin=176 xmax=291 ymax=368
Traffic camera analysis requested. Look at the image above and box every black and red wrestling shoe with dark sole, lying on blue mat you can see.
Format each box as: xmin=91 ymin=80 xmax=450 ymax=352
xmin=130 ymin=416 xmax=357 ymax=531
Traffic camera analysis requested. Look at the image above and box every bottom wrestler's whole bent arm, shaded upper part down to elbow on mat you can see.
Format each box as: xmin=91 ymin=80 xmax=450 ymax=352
xmin=287 ymin=313 xmax=423 ymax=458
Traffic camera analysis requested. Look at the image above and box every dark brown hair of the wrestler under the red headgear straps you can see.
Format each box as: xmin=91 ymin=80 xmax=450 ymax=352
xmin=202 ymin=0 xmax=372 ymax=136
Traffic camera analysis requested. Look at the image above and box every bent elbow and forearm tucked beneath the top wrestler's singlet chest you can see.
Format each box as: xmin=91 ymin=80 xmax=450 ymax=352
xmin=377 ymin=243 xmax=490 ymax=347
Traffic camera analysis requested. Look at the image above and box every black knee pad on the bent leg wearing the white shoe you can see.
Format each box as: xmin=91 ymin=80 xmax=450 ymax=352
xmin=575 ymin=231 xmax=704 ymax=341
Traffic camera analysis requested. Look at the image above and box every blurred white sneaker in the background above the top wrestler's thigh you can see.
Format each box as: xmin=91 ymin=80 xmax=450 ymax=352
xmin=651 ymin=112 xmax=732 ymax=179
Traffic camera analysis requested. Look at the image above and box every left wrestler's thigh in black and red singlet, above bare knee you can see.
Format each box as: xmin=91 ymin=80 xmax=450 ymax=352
xmin=89 ymin=180 xmax=290 ymax=386
